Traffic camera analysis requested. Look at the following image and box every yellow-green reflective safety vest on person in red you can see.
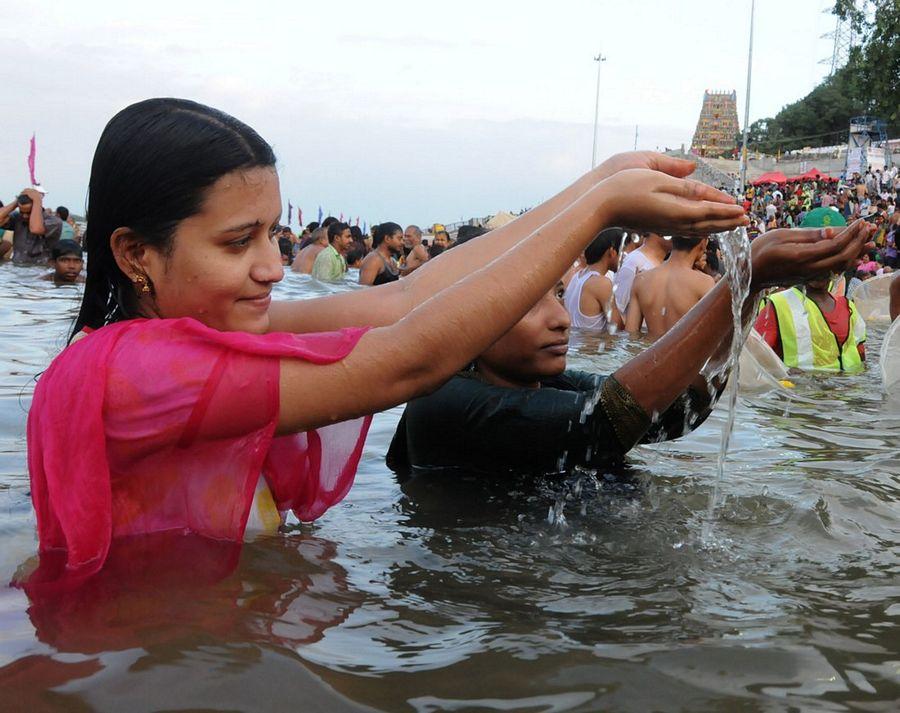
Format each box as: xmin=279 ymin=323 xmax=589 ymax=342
xmin=769 ymin=287 xmax=866 ymax=373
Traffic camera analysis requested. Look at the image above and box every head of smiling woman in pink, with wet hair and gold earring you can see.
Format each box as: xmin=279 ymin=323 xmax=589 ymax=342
xmin=74 ymin=99 xmax=284 ymax=340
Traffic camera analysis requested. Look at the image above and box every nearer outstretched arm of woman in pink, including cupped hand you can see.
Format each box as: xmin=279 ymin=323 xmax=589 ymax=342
xmin=279 ymin=170 xmax=746 ymax=433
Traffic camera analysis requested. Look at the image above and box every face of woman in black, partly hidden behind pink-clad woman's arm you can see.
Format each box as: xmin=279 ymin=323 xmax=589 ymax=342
xmin=475 ymin=282 xmax=572 ymax=387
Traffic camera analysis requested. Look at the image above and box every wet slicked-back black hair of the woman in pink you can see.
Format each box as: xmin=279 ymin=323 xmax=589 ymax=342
xmin=72 ymin=98 xmax=275 ymax=336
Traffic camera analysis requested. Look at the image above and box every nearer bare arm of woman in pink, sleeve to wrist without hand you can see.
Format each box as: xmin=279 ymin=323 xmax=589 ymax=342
xmin=279 ymin=189 xmax=606 ymax=433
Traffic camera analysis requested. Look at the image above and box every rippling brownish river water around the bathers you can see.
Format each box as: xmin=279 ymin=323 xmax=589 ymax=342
xmin=0 ymin=265 xmax=900 ymax=713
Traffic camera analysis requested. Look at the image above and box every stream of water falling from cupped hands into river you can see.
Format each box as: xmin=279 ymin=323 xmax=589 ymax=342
xmin=701 ymin=227 xmax=751 ymax=544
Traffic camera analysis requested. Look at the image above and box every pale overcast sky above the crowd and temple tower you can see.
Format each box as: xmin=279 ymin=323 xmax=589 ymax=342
xmin=0 ymin=0 xmax=834 ymax=224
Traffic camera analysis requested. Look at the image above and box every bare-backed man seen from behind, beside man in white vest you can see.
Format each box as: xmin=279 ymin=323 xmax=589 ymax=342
xmin=625 ymin=236 xmax=716 ymax=340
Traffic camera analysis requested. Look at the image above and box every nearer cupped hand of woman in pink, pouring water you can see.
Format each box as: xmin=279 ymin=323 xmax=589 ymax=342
xmin=590 ymin=166 xmax=749 ymax=235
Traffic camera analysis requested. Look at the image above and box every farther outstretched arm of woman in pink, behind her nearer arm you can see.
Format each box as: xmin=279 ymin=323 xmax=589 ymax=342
xmin=269 ymin=151 xmax=694 ymax=334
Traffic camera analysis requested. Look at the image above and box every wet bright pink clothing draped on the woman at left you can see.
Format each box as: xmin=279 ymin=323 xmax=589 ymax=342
xmin=25 ymin=318 xmax=371 ymax=591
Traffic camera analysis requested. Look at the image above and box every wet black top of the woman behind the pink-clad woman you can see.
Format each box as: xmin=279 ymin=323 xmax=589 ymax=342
xmin=387 ymin=371 xmax=711 ymax=474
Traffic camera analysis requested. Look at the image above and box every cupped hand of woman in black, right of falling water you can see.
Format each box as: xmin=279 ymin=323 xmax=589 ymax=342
xmin=751 ymin=220 xmax=875 ymax=288
